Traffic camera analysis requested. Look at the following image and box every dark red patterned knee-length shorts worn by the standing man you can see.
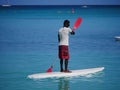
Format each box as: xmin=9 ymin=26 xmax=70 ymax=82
xmin=59 ymin=45 xmax=69 ymax=60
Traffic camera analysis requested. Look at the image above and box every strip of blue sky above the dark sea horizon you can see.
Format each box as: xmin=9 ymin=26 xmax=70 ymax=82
xmin=0 ymin=0 xmax=120 ymax=5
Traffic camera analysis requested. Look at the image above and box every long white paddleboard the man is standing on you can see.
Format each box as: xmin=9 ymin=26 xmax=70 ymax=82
xmin=28 ymin=67 xmax=104 ymax=79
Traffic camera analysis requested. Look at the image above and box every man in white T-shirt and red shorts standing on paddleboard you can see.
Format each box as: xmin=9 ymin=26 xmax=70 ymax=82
xmin=58 ymin=20 xmax=75 ymax=72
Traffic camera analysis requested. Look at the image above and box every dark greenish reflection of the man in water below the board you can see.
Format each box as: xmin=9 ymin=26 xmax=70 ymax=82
xmin=58 ymin=78 xmax=70 ymax=90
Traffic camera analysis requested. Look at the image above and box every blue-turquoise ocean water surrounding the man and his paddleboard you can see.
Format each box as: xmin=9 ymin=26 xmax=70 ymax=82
xmin=0 ymin=6 xmax=120 ymax=90
